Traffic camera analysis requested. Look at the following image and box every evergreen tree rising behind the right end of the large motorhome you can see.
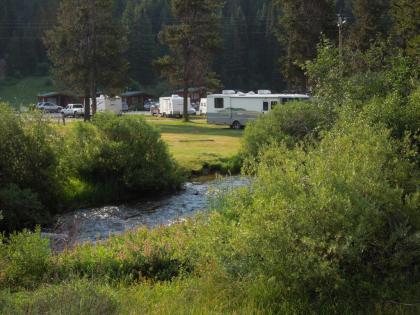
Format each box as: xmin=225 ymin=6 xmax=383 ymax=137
xmin=278 ymin=0 xmax=336 ymax=91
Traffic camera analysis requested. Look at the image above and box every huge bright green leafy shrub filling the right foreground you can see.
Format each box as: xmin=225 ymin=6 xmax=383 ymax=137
xmin=215 ymin=120 xmax=420 ymax=313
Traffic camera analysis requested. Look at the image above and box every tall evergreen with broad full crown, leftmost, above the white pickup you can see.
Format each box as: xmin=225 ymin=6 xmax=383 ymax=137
xmin=45 ymin=0 xmax=127 ymax=120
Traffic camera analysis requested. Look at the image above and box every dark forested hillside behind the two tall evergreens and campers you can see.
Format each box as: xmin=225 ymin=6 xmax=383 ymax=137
xmin=0 ymin=0 xmax=418 ymax=90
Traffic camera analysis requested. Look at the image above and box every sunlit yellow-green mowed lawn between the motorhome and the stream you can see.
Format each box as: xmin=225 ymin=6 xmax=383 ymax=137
xmin=147 ymin=119 xmax=243 ymax=171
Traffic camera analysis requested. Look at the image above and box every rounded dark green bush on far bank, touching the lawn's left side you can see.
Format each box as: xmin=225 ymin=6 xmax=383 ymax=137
xmin=93 ymin=114 xmax=181 ymax=191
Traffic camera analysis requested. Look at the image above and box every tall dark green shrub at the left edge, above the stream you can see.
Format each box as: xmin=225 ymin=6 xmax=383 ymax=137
xmin=0 ymin=104 xmax=60 ymax=232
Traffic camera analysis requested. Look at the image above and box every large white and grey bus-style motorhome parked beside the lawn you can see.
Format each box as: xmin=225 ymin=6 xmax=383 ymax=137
xmin=207 ymin=90 xmax=309 ymax=129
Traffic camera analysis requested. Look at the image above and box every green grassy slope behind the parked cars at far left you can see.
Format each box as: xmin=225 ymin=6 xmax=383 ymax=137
xmin=0 ymin=77 xmax=57 ymax=108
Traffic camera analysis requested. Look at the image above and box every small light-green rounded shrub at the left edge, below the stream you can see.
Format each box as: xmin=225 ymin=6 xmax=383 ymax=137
xmin=0 ymin=228 xmax=52 ymax=288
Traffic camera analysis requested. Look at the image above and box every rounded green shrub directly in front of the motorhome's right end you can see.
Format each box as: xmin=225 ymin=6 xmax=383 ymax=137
xmin=242 ymin=102 xmax=324 ymax=157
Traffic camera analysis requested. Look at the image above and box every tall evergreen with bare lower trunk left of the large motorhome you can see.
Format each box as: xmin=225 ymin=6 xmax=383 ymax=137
xmin=157 ymin=0 xmax=223 ymax=121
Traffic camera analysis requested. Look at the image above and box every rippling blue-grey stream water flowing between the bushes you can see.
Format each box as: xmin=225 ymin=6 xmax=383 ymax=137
xmin=44 ymin=176 xmax=250 ymax=251
